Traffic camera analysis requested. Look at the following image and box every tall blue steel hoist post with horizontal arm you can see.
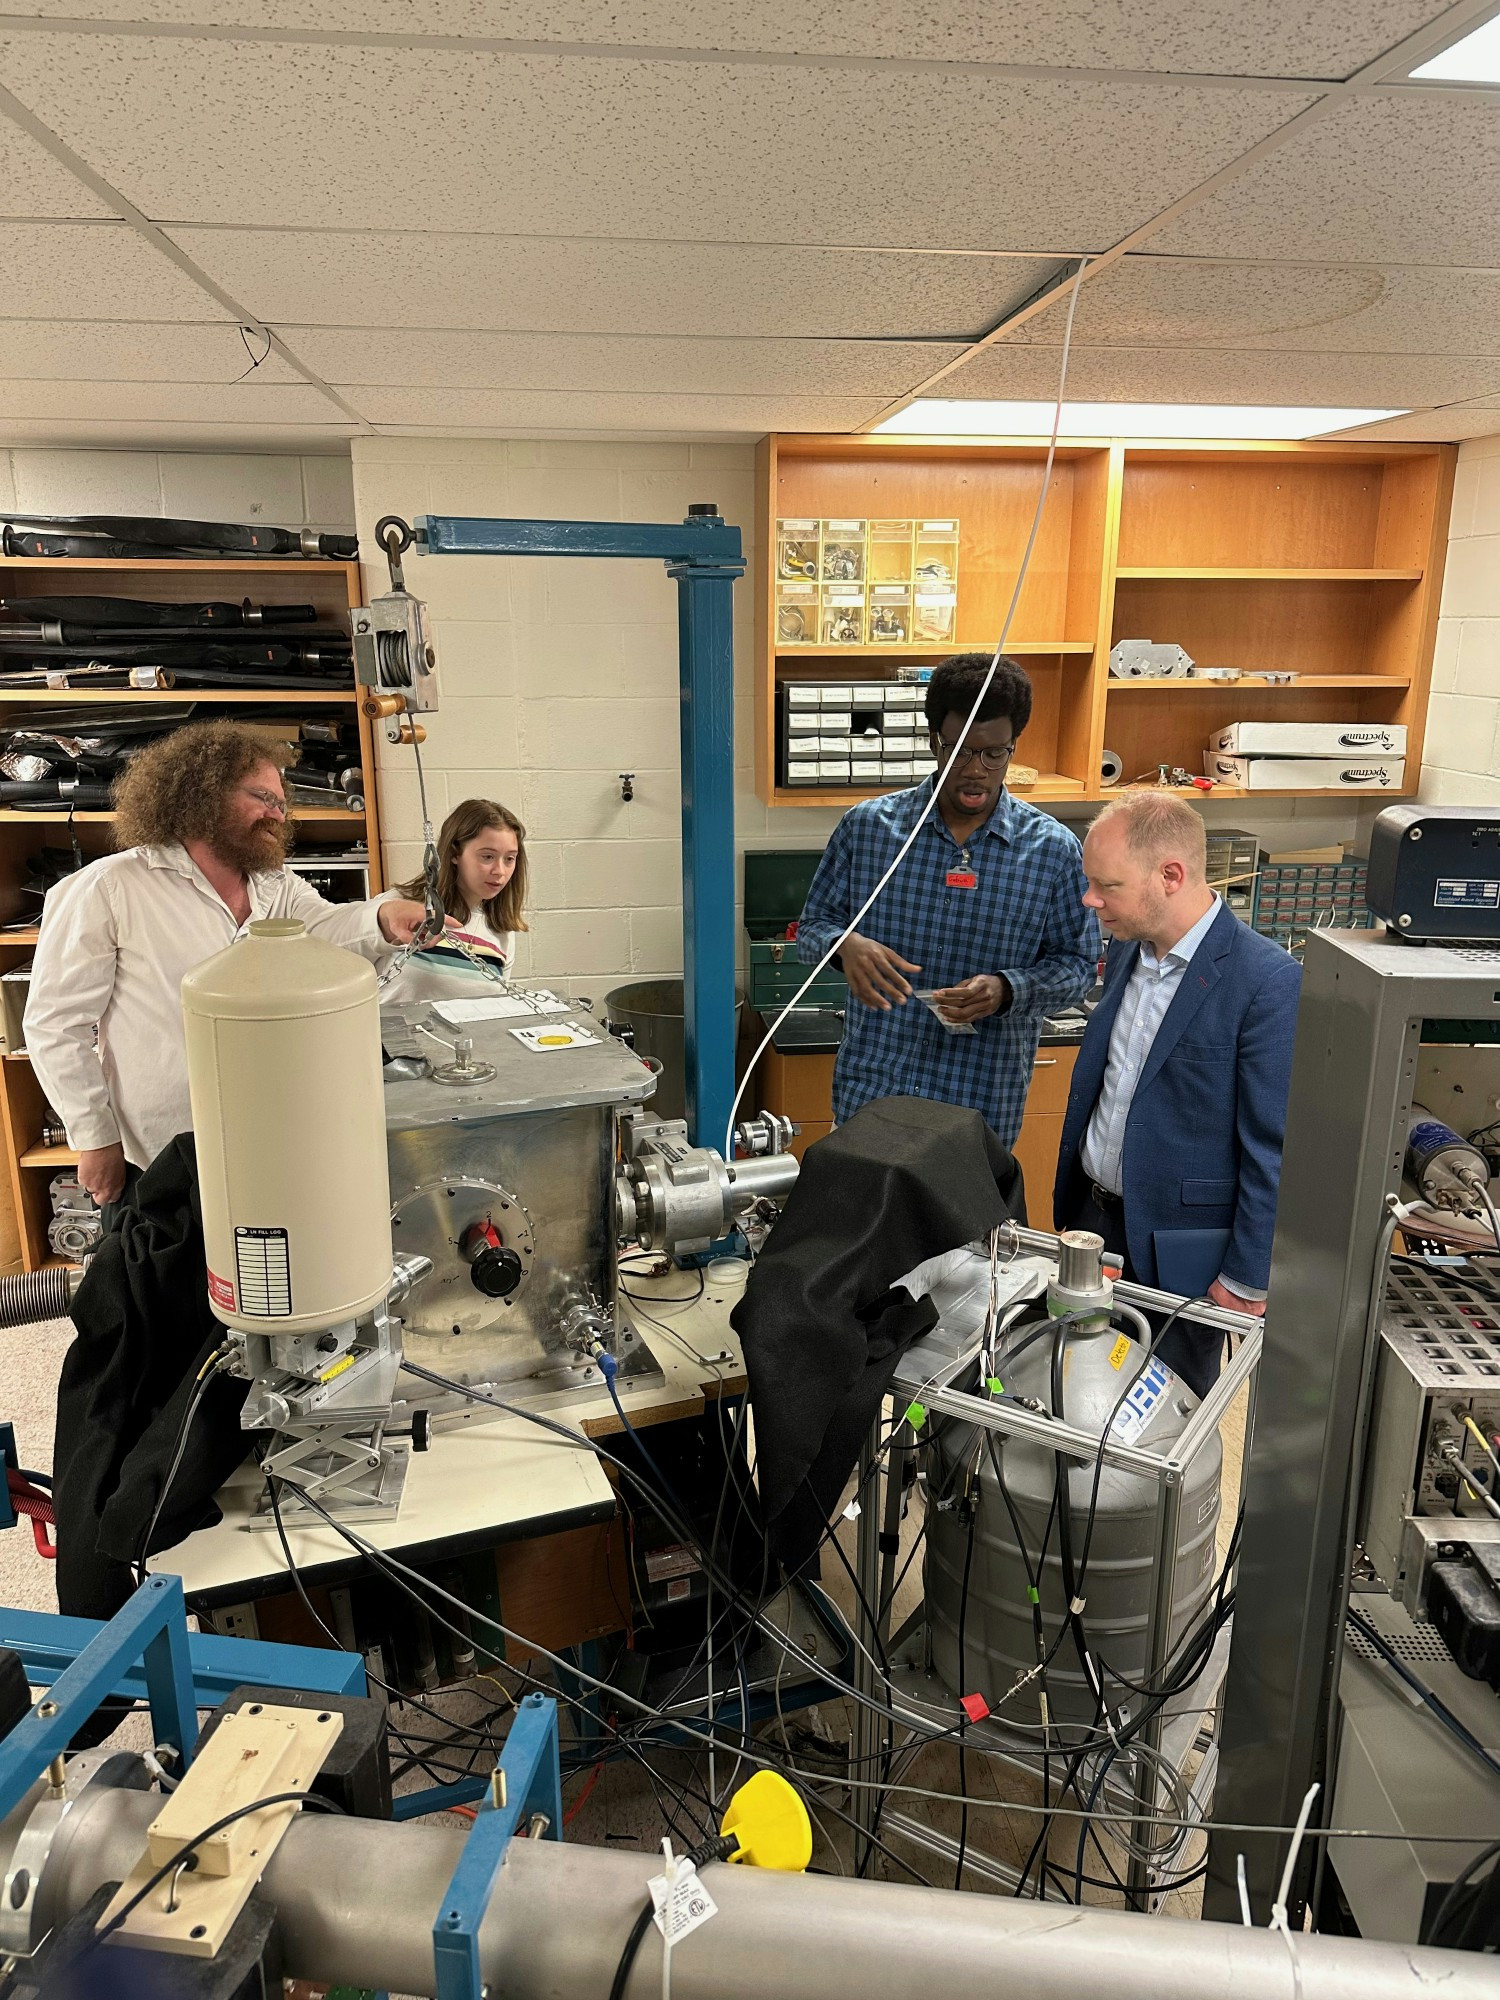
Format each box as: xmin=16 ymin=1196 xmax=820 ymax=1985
xmin=416 ymin=514 xmax=744 ymax=1146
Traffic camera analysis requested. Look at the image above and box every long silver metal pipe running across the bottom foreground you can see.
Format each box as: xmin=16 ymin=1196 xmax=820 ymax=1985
xmin=0 ymin=1788 xmax=1494 ymax=2000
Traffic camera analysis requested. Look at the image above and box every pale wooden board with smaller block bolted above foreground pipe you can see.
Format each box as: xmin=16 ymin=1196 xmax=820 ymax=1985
xmin=100 ymin=1702 xmax=344 ymax=1958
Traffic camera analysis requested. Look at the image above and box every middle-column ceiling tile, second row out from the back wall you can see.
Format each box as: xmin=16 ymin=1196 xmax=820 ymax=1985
xmin=278 ymin=326 xmax=964 ymax=396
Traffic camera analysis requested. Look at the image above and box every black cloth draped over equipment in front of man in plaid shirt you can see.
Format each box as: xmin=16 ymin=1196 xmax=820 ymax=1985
xmin=730 ymin=1098 xmax=1026 ymax=1570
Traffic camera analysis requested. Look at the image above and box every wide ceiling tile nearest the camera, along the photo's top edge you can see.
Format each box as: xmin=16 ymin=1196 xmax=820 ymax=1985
xmin=0 ymin=0 xmax=1444 ymax=76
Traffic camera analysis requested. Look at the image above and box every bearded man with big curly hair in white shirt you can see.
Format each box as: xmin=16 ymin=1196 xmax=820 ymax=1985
xmin=26 ymin=722 xmax=440 ymax=1206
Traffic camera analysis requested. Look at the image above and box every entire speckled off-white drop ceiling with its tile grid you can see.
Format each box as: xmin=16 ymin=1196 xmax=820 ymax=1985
xmin=0 ymin=0 xmax=1500 ymax=436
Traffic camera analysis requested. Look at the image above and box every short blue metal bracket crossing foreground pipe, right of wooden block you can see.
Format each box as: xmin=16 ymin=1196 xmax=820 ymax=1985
xmin=432 ymin=1694 xmax=562 ymax=2000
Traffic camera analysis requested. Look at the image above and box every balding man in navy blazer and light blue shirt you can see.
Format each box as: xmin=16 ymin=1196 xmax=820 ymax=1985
xmin=1052 ymin=792 xmax=1302 ymax=1396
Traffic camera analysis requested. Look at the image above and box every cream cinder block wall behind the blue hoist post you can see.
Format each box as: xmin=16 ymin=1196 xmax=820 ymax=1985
xmin=354 ymin=438 xmax=852 ymax=996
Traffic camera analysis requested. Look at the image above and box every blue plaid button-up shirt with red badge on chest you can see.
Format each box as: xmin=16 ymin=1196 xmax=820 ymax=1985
xmin=796 ymin=778 xmax=1100 ymax=1146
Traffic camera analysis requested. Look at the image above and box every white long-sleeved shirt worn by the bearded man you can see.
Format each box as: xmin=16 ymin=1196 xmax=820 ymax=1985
xmin=26 ymin=846 xmax=394 ymax=1166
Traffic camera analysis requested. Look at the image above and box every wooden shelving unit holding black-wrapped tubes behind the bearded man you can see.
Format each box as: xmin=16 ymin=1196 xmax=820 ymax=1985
xmin=0 ymin=558 xmax=382 ymax=1270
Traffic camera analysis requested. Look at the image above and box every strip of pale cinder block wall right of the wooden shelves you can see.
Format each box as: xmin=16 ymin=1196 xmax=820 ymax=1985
xmin=1422 ymin=438 xmax=1500 ymax=806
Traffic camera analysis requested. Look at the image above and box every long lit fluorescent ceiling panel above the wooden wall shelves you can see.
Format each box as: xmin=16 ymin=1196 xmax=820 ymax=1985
xmin=874 ymin=396 xmax=1408 ymax=438
